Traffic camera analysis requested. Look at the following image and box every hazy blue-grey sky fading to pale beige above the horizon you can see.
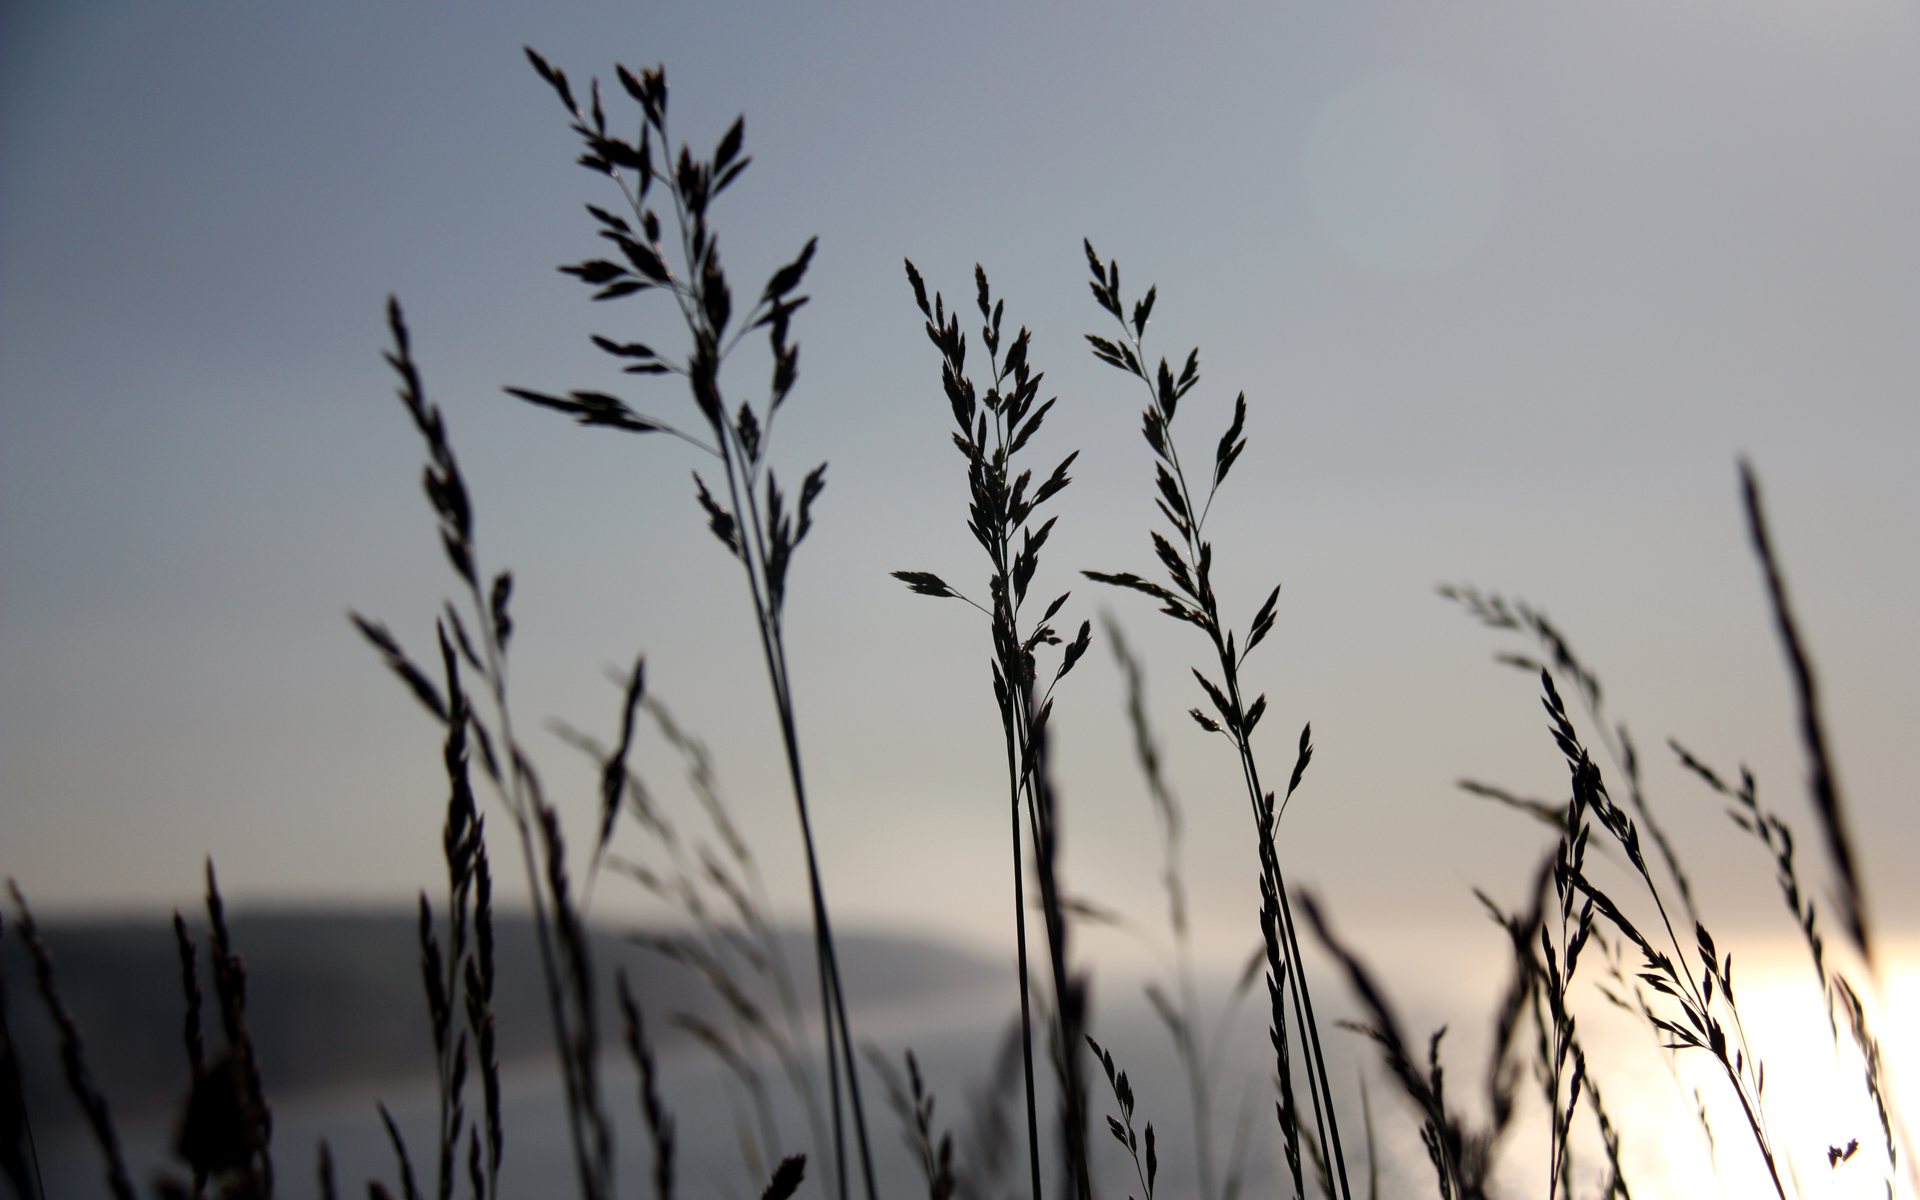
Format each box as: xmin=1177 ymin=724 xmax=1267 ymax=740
xmin=0 ymin=0 xmax=1920 ymax=983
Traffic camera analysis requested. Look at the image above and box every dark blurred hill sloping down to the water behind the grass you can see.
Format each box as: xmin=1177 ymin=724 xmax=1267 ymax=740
xmin=0 ymin=910 xmax=1010 ymax=1123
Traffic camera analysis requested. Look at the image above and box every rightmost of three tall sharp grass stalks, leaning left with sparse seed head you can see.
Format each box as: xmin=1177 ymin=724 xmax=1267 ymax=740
xmin=1081 ymin=242 xmax=1352 ymax=1200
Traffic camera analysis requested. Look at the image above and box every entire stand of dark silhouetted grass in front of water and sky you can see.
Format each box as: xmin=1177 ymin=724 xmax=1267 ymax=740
xmin=0 ymin=50 xmax=1920 ymax=1200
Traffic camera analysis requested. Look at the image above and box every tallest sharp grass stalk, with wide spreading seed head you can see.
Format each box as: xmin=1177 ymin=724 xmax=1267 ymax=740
xmin=507 ymin=48 xmax=877 ymax=1200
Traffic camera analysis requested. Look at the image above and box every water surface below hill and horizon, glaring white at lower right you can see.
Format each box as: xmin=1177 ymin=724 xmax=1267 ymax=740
xmin=40 ymin=941 xmax=1920 ymax=1200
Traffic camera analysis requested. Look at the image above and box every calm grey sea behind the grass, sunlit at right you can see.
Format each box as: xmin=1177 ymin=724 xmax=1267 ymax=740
xmin=26 ymin=948 xmax=1905 ymax=1200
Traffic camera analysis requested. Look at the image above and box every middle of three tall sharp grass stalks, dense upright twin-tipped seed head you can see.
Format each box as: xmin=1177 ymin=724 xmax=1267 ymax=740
xmin=893 ymin=261 xmax=1092 ymax=1200
